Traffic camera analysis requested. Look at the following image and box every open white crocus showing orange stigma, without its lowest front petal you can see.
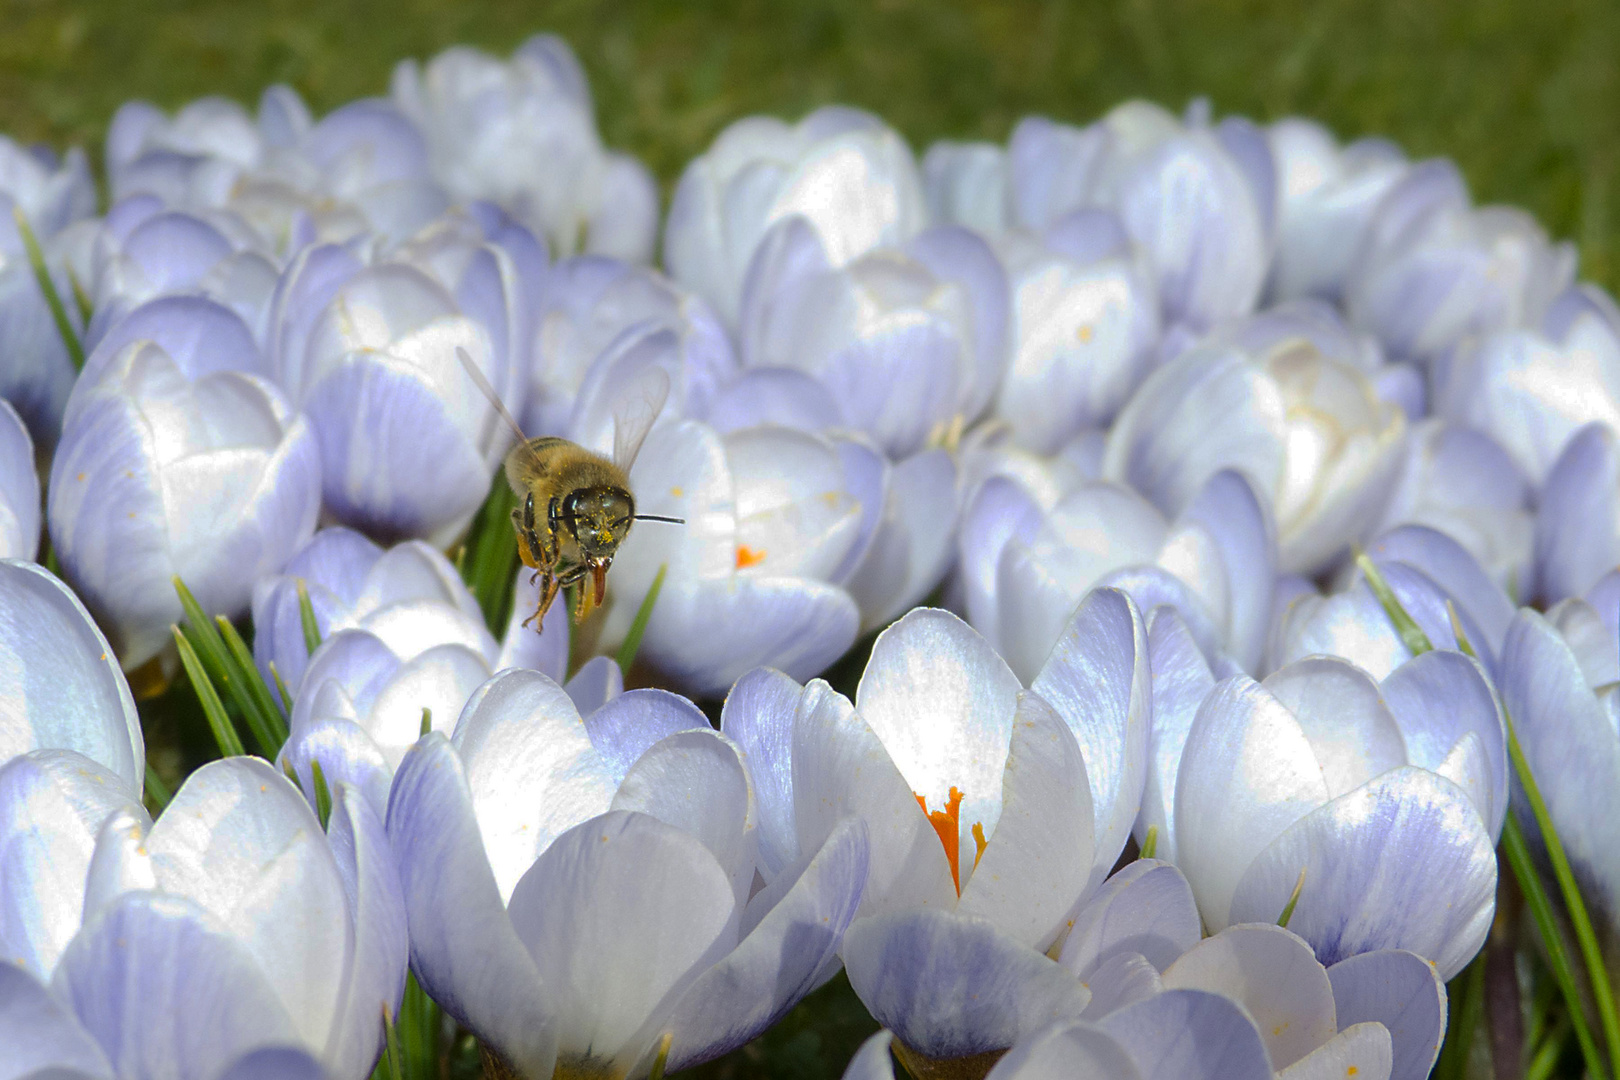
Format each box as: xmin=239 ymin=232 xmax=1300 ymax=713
xmin=721 ymin=589 xmax=1147 ymax=957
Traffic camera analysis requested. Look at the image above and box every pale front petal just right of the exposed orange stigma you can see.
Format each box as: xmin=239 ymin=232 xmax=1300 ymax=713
xmin=957 ymin=691 xmax=1094 ymax=949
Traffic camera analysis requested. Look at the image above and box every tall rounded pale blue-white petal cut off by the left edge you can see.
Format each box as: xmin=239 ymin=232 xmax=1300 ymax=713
xmin=0 ymin=560 xmax=146 ymax=795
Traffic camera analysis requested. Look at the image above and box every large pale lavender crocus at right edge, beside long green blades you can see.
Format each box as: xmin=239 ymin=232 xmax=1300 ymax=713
xmin=1499 ymin=586 xmax=1620 ymax=926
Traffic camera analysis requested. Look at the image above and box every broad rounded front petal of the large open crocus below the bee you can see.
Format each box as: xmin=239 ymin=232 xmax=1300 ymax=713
xmin=509 ymin=811 xmax=737 ymax=1067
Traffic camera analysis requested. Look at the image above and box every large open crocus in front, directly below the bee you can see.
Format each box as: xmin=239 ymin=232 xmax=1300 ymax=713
xmin=389 ymin=670 xmax=867 ymax=1080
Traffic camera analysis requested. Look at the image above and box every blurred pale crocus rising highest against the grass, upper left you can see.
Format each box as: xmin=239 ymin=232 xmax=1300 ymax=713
xmin=392 ymin=34 xmax=658 ymax=262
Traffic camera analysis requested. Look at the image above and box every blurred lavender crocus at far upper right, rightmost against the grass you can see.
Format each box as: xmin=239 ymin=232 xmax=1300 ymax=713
xmin=1345 ymin=160 xmax=1575 ymax=359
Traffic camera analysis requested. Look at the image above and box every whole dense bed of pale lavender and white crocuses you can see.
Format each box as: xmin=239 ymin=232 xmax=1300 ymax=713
xmin=0 ymin=29 xmax=1620 ymax=1080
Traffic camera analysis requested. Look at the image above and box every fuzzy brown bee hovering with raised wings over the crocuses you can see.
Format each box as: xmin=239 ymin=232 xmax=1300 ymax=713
xmin=455 ymin=348 xmax=685 ymax=633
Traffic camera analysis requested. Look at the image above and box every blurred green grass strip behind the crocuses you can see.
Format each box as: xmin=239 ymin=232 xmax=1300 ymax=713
xmin=0 ymin=0 xmax=1620 ymax=287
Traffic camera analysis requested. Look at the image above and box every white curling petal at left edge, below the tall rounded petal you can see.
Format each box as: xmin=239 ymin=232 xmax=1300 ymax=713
xmin=0 ymin=750 xmax=146 ymax=980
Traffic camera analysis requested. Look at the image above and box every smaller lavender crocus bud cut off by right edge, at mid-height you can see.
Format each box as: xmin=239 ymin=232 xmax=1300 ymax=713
xmin=1534 ymin=424 xmax=1620 ymax=602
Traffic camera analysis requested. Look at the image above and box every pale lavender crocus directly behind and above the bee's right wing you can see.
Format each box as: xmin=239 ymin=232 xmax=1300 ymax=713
xmin=518 ymin=256 xmax=737 ymax=436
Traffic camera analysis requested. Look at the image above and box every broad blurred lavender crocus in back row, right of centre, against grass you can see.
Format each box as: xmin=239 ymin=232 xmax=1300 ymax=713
xmin=1008 ymin=102 xmax=1275 ymax=330
